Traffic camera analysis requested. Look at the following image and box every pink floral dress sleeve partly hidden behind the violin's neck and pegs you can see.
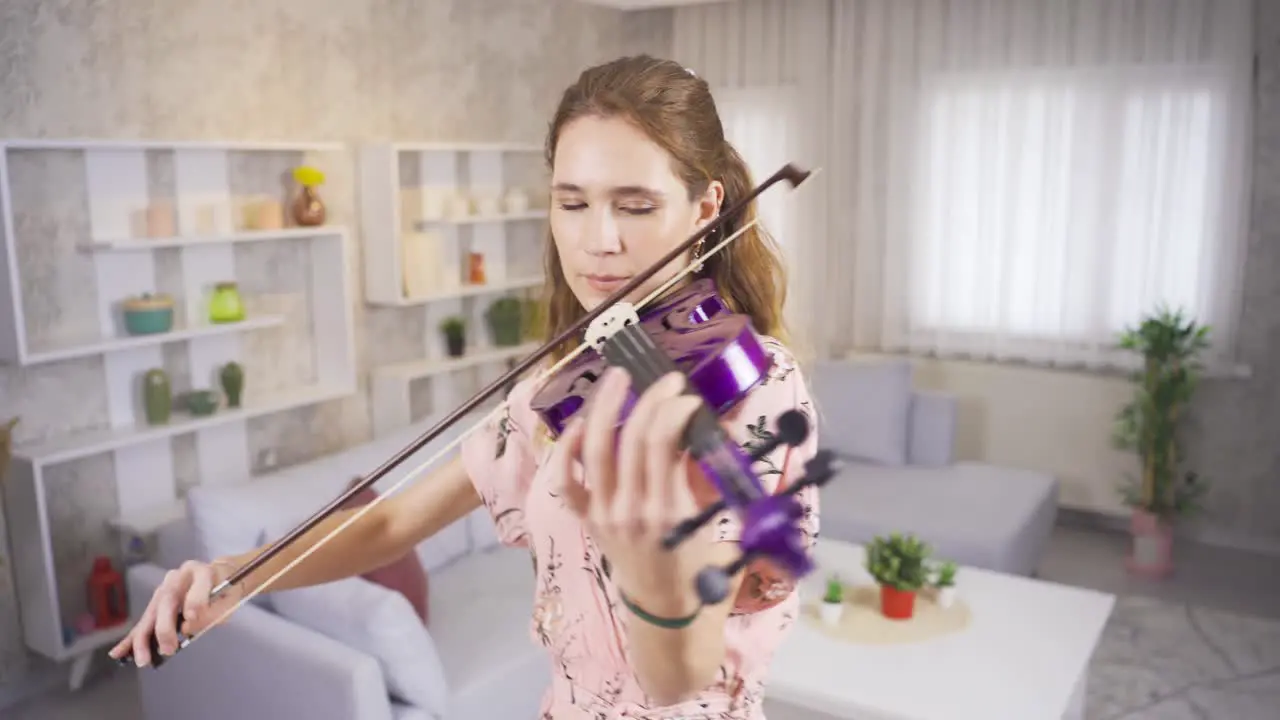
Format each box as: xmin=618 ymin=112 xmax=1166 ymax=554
xmin=714 ymin=342 xmax=818 ymax=614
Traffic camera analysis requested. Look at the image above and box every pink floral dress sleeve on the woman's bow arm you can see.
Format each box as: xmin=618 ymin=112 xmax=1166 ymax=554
xmin=462 ymin=383 xmax=536 ymax=547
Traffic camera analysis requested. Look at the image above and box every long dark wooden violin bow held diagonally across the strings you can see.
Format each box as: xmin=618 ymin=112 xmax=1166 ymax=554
xmin=116 ymin=163 xmax=819 ymax=669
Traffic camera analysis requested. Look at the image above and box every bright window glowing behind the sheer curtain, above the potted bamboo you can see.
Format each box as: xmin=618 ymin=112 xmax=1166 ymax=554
xmin=902 ymin=68 xmax=1244 ymax=359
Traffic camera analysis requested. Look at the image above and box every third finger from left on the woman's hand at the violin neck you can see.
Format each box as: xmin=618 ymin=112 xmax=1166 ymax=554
xmin=611 ymin=373 xmax=685 ymax=533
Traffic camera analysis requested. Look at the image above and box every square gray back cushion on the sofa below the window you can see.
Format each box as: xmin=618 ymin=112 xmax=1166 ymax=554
xmin=810 ymin=359 xmax=911 ymax=466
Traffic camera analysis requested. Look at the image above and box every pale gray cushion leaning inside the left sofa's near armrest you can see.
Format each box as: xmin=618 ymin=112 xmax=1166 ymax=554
xmin=273 ymin=578 xmax=448 ymax=717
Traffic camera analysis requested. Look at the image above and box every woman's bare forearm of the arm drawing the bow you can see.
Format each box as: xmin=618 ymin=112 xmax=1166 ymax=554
xmin=215 ymin=460 xmax=480 ymax=593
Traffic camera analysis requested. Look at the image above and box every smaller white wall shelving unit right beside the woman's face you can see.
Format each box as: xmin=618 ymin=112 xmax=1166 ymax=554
xmin=360 ymin=142 xmax=548 ymax=436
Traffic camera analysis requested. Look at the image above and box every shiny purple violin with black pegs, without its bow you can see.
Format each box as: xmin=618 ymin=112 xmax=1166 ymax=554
xmin=531 ymin=278 xmax=833 ymax=605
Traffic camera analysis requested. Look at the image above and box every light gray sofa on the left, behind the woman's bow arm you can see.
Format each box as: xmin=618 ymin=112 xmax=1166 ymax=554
xmin=128 ymin=421 xmax=550 ymax=720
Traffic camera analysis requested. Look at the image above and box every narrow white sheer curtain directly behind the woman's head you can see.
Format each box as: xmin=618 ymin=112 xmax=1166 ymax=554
xmin=672 ymin=0 xmax=835 ymax=359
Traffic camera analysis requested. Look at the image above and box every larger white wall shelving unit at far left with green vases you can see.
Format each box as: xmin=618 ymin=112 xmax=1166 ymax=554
xmin=0 ymin=140 xmax=356 ymax=687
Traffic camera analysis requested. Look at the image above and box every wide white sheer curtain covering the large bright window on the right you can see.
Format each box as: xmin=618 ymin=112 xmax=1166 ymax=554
xmin=831 ymin=0 xmax=1252 ymax=366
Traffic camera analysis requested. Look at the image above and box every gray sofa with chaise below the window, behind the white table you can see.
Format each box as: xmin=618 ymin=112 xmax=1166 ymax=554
xmin=809 ymin=359 xmax=1059 ymax=575
